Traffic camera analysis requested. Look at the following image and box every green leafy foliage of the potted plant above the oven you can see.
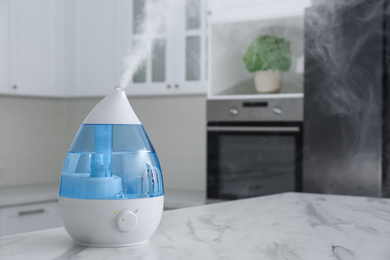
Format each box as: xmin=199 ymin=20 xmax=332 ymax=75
xmin=243 ymin=35 xmax=291 ymax=72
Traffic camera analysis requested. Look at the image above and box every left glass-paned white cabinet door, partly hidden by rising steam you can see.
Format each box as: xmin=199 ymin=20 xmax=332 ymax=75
xmin=126 ymin=0 xmax=174 ymax=95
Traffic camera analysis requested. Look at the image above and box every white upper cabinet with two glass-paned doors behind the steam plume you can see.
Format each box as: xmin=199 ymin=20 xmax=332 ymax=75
xmin=126 ymin=0 xmax=206 ymax=95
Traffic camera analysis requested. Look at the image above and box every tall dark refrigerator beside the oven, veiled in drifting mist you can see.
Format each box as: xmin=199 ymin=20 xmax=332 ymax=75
xmin=304 ymin=0 xmax=384 ymax=196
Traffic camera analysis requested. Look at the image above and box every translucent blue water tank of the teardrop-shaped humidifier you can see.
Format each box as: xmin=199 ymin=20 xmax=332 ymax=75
xmin=60 ymin=125 xmax=164 ymax=199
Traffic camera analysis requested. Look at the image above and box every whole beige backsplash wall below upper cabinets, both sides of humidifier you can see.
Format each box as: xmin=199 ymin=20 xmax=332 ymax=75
xmin=0 ymin=95 xmax=206 ymax=191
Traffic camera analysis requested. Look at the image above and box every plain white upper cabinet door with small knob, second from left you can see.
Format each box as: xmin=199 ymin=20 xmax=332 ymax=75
xmin=8 ymin=0 xmax=61 ymax=96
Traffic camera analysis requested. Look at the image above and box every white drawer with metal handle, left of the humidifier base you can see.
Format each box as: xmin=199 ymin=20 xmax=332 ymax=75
xmin=0 ymin=201 xmax=62 ymax=236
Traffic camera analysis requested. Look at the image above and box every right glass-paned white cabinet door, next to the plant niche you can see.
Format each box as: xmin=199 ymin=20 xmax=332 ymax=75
xmin=175 ymin=0 xmax=207 ymax=93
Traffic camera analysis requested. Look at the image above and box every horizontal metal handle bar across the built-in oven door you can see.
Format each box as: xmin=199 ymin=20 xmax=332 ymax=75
xmin=207 ymin=126 xmax=299 ymax=133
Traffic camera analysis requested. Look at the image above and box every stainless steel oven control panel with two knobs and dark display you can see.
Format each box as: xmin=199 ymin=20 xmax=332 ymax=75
xmin=207 ymin=97 xmax=303 ymax=122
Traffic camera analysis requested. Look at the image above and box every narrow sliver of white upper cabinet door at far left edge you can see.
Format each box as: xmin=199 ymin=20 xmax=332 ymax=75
xmin=0 ymin=0 xmax=9 ymax=94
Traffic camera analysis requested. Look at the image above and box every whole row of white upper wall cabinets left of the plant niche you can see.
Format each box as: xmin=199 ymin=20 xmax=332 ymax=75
xmin=0 ymin=0 xmax=206 ymax=97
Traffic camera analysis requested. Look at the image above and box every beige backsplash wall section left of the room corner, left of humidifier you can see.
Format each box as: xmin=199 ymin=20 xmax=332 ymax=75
xmin=0 ymin=97 xmax=69 ymax=186
